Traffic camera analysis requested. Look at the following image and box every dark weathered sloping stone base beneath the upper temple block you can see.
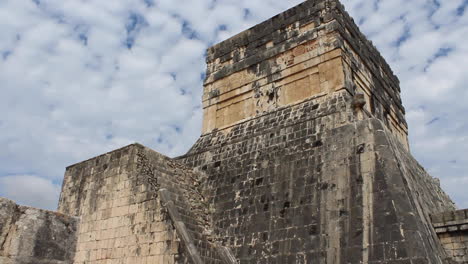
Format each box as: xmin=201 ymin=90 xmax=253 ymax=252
xmin=180 ymin=90 xmax=453 ymax=263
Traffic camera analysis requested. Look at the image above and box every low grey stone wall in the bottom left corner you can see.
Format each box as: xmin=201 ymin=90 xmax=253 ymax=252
xmin=0 ymin=198 xmax=78 ymax=264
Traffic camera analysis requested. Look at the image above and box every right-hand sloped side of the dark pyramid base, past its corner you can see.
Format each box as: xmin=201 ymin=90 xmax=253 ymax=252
xmin=357 ymin=119 xmax=455 ymax=263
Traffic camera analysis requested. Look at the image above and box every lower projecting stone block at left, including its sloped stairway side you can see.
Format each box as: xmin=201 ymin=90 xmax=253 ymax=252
xmin=59 ymin=144 xmax=230 ymax=263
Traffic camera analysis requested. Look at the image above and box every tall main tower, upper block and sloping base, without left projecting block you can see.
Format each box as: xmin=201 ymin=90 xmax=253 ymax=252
xmin=180 ymin=0 xmax=454 ymax=263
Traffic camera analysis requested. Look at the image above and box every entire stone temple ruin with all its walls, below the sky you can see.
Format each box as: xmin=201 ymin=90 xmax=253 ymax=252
xmin=0 ymin=0 xmax=468 ymax=264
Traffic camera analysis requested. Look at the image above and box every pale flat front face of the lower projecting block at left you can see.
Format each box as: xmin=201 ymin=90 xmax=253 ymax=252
xmin=59 ymin=145 xmax=184 ymax=264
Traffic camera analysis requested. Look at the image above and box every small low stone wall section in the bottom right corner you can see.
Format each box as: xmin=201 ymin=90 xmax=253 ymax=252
xmin=431 ymin=209 xmax=468 ymax=263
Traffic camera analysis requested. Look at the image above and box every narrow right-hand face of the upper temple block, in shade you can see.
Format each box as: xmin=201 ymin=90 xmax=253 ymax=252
xmin=331 ymin=2 xmax=409 ymax=149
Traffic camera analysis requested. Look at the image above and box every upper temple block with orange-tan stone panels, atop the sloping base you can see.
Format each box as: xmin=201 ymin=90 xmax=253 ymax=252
xmin=203 ymin=0 xmax=408 ymax=148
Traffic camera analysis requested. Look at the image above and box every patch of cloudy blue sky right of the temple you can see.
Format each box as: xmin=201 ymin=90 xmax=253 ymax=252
xmin=344 ymin=0 xmax=468 ymax=207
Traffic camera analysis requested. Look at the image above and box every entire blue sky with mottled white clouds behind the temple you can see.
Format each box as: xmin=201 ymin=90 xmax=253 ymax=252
xmin=0 ymin=0 xmax=468 ymax=209
